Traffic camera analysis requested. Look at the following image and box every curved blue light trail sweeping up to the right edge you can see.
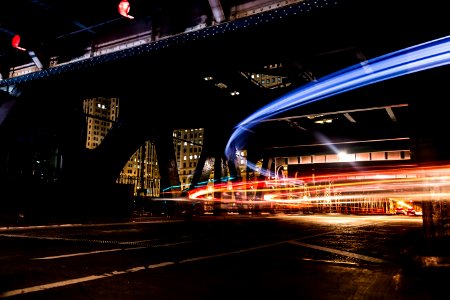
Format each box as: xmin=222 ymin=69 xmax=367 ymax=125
xmin=225 ymin=36 xmax=450 ymax=166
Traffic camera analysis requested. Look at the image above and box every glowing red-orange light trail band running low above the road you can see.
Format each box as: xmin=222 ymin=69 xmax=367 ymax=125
xmin=189 ymin=164 xmax=450 ymax=215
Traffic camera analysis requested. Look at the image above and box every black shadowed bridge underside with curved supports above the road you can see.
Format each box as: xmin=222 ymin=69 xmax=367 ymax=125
xmin=0 ymin=1 xmax=449 ymax=223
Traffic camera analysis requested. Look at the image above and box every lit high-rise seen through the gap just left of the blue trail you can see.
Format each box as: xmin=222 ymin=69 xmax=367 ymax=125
xmin=173 ymin=128 xmax=204 ymax=191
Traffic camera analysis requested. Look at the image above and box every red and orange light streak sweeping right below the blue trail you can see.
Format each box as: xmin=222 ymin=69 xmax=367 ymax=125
xmin=189 ymin=165 xmax=450 ymax=207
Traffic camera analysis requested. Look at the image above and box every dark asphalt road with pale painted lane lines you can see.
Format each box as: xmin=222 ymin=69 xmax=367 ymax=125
xmin=0 ymin=215 xmax=442 ymax=300
